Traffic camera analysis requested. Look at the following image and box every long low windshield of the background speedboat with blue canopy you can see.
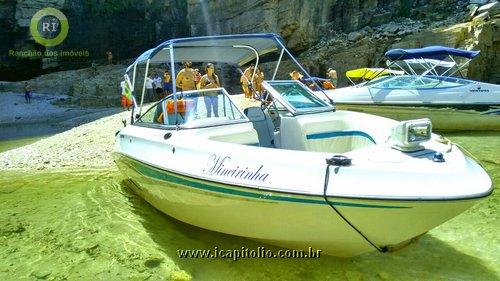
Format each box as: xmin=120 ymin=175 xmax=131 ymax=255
xmin=365 ymin=75 xmax=472 ymax=89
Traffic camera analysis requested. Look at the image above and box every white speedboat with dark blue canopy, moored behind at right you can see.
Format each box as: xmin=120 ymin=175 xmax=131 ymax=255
xmin=327 ymin=46 xmax=500 ymax=130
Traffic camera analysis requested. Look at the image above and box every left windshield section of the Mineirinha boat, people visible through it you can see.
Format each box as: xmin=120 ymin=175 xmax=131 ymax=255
xmin=136 ymin=88 xmax=248 ymax=128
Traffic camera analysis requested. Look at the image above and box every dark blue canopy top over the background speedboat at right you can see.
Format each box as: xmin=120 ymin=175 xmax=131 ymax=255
xmin=385 ymin=46 xmax=479 ymax=61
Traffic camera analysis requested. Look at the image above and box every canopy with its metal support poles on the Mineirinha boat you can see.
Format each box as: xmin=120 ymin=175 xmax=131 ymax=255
xmin=126 ymin=33 xmax=328 ymax=119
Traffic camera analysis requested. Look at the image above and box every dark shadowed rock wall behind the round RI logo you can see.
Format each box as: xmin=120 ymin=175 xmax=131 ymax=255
xmin=0 ymin=0 xmax=189 ymax=80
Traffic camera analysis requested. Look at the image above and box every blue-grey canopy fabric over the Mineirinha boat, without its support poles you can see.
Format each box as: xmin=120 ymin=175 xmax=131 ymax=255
xmin=127 ymin=33 xmax=284 ymax=71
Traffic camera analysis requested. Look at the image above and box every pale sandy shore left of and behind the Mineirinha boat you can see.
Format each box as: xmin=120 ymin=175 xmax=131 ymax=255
xmin=0 ymin=95 xmax=258 ymax=170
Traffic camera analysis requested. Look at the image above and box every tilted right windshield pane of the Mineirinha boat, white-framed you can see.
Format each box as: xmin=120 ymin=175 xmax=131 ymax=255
xmin=263 ymin=80 xmax=334 ymax=115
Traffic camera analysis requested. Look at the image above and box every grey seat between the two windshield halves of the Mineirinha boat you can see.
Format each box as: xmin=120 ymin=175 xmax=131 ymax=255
xmin=244 ymin=106 xmax=275 ymax=147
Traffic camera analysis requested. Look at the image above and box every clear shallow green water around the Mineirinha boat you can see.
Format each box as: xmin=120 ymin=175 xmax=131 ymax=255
xmin=0 ymin=133 xmax=500 ymax=280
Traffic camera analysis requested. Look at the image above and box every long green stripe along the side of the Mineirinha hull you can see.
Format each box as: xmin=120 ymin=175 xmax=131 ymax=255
xmin=120 ymin=155 xmax=411 ymax=209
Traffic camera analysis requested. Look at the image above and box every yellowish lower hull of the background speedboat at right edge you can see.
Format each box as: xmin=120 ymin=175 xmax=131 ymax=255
xmin=337 ymin=103 xmax=500 ymax=131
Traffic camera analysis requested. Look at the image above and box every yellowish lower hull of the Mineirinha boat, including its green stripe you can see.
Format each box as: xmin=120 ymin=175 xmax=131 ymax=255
xmin=115 ymin=153 xmax=476 ymax=257
